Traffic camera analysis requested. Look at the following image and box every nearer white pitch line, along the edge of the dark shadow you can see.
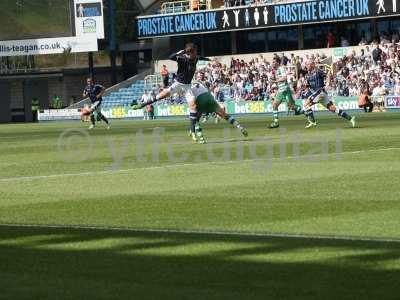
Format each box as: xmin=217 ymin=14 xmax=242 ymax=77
xmin=0 ymin=223 xmax=400 ymax=244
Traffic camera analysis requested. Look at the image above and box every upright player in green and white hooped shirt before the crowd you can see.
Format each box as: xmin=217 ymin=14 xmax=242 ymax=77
xmin=269 ymin=57 xmax=303 ymax=128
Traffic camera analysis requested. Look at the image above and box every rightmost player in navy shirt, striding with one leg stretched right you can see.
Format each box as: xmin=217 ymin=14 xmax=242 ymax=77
xmin=304 ymin=61 xmax=356 ymax=128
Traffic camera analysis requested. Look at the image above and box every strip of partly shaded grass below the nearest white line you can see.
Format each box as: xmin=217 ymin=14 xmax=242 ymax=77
xmin=0 ymin=226 xmax=400 ymax=299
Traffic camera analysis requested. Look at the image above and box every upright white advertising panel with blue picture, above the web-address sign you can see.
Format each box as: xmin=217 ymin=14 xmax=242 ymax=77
xmin=74 ymin=0 xmax=104 ymax=39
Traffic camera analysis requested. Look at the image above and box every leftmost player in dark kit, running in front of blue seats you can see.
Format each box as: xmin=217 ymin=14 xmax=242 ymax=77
xmin=82 ymin=78 xmax=110 ymax=130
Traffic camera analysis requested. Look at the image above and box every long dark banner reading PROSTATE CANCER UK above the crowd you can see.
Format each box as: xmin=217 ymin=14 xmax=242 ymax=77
xmin=136 ymin=0 xmax=400 ymax=38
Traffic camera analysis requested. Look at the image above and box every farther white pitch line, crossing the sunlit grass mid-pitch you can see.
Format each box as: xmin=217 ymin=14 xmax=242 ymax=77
xmin=0 ymin=147 xmax=400 ymax=183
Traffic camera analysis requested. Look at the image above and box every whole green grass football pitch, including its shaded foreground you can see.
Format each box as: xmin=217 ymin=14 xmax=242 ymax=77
xmin=0 ymin=113 xmax=400 ymax=299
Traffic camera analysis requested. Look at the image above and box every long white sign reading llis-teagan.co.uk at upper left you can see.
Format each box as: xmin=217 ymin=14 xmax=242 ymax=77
xmin=0 ymin=36 xmax=98 ymax=57
